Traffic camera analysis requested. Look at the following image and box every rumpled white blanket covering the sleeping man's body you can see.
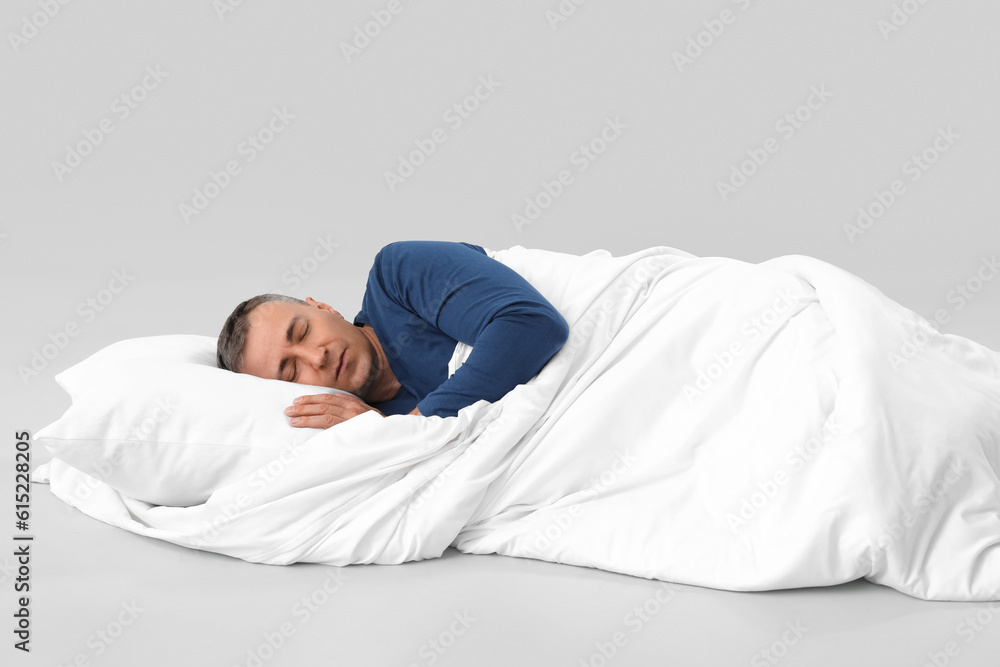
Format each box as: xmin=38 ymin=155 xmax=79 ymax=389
xmin=34 ymin=246 xmax=1000 ymax=600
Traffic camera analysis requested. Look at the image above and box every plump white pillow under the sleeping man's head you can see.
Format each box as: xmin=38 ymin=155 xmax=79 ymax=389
xmin=35 ymin=334 xmax=348 ymax=507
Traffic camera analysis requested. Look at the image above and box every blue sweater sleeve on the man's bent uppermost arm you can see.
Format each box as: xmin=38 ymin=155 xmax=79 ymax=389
xmin=375 ymin=241 xmax=569 ymax=417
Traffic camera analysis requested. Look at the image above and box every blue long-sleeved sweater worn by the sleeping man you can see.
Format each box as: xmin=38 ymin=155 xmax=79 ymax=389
xmin=354 ymin=241 xmax=569 ymax=417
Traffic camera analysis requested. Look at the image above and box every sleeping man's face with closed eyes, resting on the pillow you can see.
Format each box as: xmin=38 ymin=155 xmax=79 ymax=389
xmin=243 ymin=298 xmax=379 ymax=400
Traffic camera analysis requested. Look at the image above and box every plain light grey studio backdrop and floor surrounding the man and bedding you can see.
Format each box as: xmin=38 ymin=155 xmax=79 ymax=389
xmin=0 ymin=0 xmax=1000 ymax=665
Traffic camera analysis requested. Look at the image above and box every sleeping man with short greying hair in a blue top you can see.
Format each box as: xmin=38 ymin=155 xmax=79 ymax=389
xmin=217 ymin=241 xmax=569 ymax=428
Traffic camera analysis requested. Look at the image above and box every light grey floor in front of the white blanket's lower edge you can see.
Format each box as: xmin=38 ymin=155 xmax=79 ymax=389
xmin=7 ymin=452 xmax=1000 ymax=667
